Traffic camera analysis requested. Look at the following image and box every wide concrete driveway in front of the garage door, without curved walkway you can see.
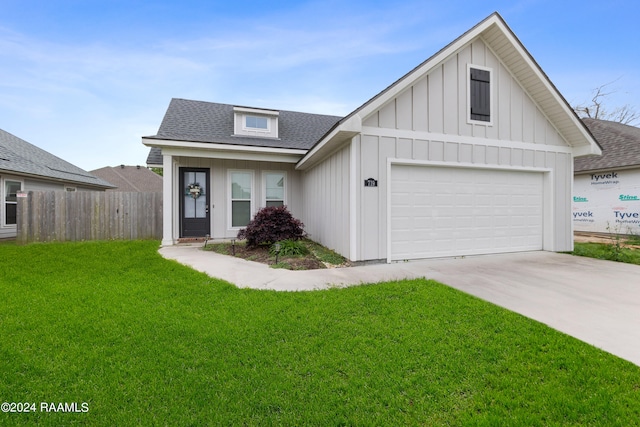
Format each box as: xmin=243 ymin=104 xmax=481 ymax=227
xmin=416 ymin=252 xmax=640 ymax=366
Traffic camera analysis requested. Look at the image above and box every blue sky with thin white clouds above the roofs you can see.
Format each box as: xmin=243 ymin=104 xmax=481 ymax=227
xmin=0 ymin=0 xmax=640 ymax=170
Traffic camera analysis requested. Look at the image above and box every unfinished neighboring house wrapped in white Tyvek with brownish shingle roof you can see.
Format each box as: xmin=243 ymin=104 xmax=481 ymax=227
xmin=573 ymin=119 xmax=640 ymax=235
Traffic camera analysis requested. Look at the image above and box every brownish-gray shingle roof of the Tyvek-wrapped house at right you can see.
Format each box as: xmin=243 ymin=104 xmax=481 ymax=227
xmin=574 ymin=119 xmax=640 ymax=172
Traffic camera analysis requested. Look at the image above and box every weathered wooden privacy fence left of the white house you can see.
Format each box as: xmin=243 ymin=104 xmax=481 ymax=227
xmin=16 ymin=191 xmax=162 ymax=244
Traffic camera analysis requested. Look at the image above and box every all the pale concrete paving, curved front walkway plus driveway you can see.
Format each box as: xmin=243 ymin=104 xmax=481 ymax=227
xmin=160 ymin=246 xmax=640 ymax=366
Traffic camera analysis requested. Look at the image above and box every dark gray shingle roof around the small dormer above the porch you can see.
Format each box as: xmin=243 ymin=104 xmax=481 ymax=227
xmin=149 ymin=98 xmax=342 ymax=150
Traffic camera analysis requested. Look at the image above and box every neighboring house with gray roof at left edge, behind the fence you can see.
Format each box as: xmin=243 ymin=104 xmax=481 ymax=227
xmin=0 ymin=129 xmax=112 ymax=238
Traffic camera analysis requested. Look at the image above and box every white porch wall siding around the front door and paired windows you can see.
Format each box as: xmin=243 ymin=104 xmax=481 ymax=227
xmin=172 ymin=157 xmax=303 ymax=239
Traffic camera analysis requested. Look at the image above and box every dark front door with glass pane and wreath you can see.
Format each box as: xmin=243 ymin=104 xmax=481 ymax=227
xmin=179 ymin=168 xmax=211 ymax=237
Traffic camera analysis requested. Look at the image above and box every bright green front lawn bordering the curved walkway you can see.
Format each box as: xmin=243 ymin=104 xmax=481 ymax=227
xmin=0 ymin=242 xmax=640 ymax=426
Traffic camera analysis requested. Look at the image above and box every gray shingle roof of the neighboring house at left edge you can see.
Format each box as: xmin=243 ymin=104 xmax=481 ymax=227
xmin=0 ymin=129 xmax=112 ymax=188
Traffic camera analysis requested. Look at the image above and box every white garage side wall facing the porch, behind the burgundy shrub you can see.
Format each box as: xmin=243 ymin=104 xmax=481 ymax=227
xmin=302 ymin=145 xmax=351 ymax=258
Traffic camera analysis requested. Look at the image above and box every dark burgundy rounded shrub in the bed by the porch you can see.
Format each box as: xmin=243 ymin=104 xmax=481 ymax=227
xmin=238 ymin=206 xmax=306 ymax=247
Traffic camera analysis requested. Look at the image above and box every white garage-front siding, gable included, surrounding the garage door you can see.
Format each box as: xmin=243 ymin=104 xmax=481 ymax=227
xmin=353 ymin=39 xmax=573 ymax=260
